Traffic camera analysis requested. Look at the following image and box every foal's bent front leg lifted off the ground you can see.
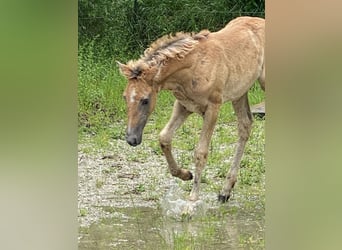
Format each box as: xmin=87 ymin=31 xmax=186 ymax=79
xmin=159 ymin=101 xmax=192 ymax=180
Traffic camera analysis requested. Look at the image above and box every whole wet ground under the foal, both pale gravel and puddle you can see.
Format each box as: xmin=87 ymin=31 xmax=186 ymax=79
xmin=78 ymin=124 xmax=265 ymax=249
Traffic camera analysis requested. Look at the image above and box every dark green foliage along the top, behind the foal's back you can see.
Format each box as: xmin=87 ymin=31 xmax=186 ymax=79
xmin=78 ymin=0 xmax=265 ymax=60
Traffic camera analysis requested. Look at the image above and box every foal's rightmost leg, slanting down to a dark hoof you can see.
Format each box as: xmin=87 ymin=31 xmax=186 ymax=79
xmin=218 ymin=93 xmax=253 ymax=202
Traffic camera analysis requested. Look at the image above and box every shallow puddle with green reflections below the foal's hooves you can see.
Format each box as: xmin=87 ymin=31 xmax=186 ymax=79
xmin=79 ymin=200 xmax=264 ymax=250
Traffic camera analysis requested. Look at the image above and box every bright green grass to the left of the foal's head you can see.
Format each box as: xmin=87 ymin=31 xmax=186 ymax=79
xmin=78 ymin=44 xmax=125 ymax=141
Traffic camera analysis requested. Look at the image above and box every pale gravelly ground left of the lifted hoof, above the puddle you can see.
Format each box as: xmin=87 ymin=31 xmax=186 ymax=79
xmin=78 ymin=140 xmax=171 ymax=227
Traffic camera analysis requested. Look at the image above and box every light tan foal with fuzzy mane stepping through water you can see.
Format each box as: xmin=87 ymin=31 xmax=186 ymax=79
xmin=118 ymin=17 xmax=265 ymax=202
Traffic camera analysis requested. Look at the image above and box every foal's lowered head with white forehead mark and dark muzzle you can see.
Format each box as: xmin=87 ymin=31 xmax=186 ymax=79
xmin=118 ymin=63 xmax=158 ymax=147
